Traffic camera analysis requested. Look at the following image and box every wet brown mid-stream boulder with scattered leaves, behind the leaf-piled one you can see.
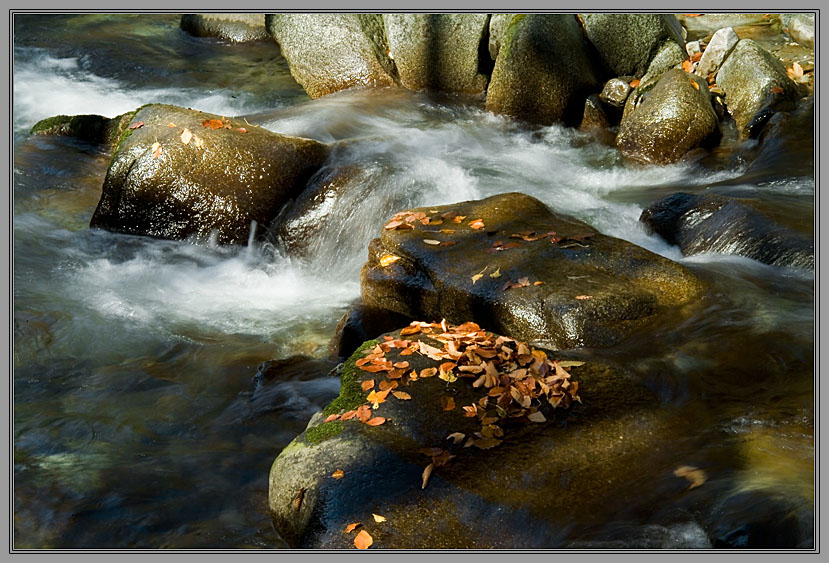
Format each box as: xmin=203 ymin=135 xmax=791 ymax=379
xmin=360 ymin=193 xmax=703 ymax=349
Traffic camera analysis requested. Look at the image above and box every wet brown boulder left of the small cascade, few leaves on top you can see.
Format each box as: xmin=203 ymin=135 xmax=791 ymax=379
xmin=90 ymin=104 xmax=329 ymax=244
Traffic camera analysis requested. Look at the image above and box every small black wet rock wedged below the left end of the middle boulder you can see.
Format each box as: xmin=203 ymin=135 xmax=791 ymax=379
xmin=328 ymin=303 xmax=413 ymax=358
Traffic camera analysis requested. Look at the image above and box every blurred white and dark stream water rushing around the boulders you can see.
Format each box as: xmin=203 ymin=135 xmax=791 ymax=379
xmin=13 ymin=15 xmax=815 ymax=548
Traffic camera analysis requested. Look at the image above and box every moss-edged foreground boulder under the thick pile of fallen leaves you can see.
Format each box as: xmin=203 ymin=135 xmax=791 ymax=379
xmin=268 ymin=327 xmax=696 ymax=549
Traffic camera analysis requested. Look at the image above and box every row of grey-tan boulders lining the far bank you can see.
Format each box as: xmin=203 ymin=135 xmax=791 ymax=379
xmin=182 ymin=13 xmax=814 ymax=163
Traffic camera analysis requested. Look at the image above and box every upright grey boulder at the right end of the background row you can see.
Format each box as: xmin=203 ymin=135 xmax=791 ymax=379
xmin=717 ymin=39 xmax=802 ymax=138
